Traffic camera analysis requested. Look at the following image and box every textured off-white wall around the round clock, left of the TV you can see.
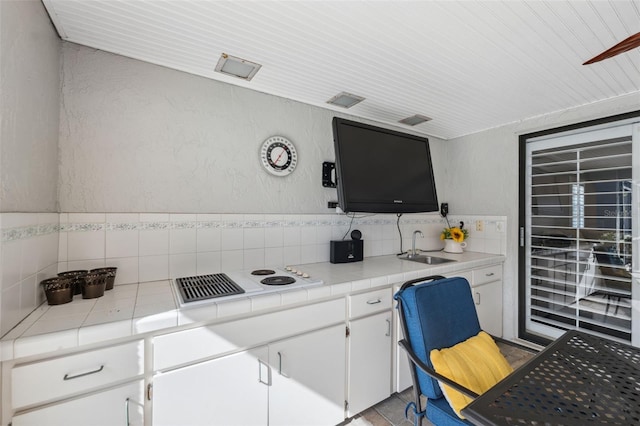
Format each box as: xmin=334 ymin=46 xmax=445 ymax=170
xmin=59 ymin=43 xmax=448 ymax=213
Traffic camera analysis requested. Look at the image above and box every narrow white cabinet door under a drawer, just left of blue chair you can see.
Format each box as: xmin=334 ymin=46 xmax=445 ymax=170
xmin=347 ymin=312 xmax=391 ymax=417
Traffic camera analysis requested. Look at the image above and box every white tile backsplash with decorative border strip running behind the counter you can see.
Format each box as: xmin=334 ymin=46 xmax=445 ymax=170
xmin=0 ymin=213 xmax=506 ymax=335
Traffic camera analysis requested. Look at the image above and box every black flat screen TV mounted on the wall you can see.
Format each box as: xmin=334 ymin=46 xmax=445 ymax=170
xmin=333 ymin=117 xmax=438 ymax=213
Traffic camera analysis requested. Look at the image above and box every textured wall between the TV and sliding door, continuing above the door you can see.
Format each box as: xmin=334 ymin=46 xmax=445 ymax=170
xmin=442 ymin=93 xmax=640 ymax=338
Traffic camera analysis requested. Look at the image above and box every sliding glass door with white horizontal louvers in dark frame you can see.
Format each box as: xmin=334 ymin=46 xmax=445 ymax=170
xmin=520 ymin=115 xmax=640 ymax=344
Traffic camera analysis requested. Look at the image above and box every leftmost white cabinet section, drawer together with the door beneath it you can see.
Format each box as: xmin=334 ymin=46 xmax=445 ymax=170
xmin=3 ymin=340 xmax=144 ymax=426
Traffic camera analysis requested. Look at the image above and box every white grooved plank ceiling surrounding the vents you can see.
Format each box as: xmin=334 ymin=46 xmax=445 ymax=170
xmin=43 ymin=0 xmax=640 ymax=139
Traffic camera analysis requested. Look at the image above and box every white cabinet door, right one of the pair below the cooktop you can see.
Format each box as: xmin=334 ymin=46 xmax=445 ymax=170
xmin=269 ymin=324 xmax=346 ymax=426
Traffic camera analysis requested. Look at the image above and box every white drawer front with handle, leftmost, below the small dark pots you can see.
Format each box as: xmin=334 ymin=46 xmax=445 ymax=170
xmin=11 ymin=340 xmax=144 ymax=409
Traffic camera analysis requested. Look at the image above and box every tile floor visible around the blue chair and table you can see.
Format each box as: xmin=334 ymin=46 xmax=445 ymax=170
xmin=345 ymin=343 xmax=535 ymax=426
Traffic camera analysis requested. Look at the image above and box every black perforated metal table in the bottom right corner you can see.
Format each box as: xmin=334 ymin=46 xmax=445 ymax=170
xmin=462 ymin=330 xmax=640 ymax=426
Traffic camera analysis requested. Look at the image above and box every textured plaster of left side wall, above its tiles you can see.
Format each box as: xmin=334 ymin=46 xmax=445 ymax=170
xmin=0 ymin=0 xmax=60 ymax=212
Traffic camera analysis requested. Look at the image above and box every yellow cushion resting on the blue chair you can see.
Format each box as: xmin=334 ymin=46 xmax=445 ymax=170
xmin=429 ymin=331 xmax=513 ymax=419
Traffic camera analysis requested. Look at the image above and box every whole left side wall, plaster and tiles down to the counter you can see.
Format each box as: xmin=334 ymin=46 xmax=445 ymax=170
xmin=0 ymin=0 xmax=60 ymax=334
